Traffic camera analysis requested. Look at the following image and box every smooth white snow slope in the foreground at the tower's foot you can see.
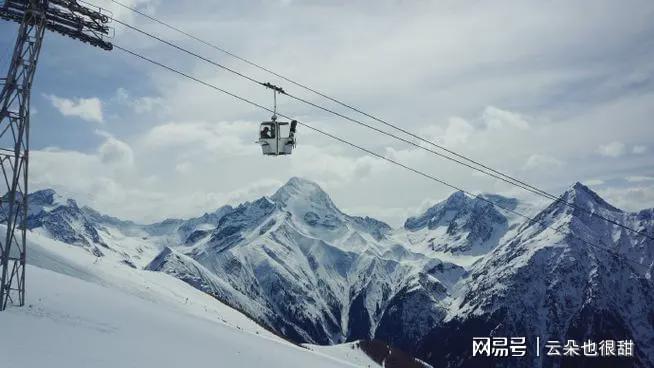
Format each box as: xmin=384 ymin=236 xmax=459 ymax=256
xmin=0 ymin=230 xmax=364 ymax=368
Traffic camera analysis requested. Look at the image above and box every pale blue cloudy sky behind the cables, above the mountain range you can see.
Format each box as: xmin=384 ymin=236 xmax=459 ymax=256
xmin=0 ymin=0 xmax=654 ymax=226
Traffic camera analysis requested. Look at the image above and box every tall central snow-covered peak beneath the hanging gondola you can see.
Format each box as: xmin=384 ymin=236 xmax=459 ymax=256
xmin=148 ymin=178 xmax=456 ymax=344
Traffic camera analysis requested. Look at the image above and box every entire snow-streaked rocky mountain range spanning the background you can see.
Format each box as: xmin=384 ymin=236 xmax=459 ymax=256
xmin=7 ymin=178 xmax=654 ymax=367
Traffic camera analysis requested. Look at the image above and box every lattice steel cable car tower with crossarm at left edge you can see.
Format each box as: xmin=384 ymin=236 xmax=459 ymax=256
xmin=0 ymin=0 xmax=112 ymax=311
